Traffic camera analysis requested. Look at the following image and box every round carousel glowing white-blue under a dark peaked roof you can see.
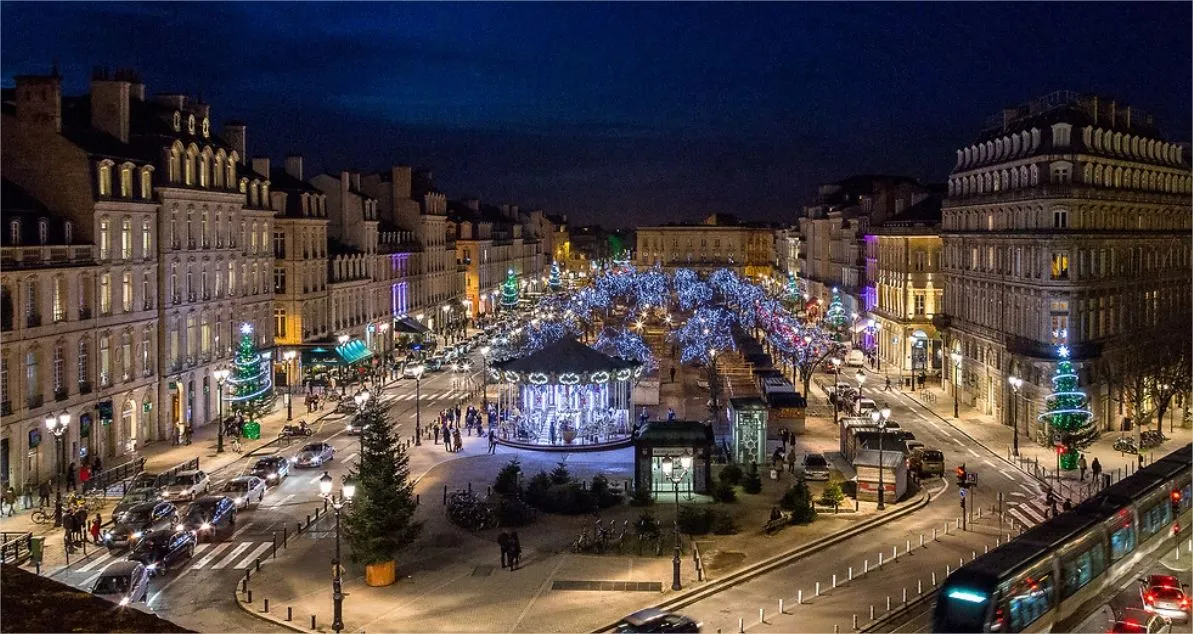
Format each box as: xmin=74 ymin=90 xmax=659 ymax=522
xmin=489 ymin=337 xmax=642 ymax=451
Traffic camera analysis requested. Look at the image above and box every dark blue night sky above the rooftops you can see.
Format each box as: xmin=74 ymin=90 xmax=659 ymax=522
xmin=0 ymin=2 xmax=1193 ymax=226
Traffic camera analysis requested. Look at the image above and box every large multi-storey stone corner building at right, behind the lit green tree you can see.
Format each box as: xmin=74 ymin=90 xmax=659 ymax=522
xmin=941 ymin=92 xmax=1191 ymax=441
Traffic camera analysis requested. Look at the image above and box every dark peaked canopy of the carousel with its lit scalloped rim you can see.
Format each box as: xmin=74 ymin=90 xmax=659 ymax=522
xmin=490 ymin=337 xmax=642 ymax=384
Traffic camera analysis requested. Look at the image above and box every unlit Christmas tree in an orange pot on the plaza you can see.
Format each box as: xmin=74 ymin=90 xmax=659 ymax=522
xmin=345 ymin=402 xmax=422 ymax=586
